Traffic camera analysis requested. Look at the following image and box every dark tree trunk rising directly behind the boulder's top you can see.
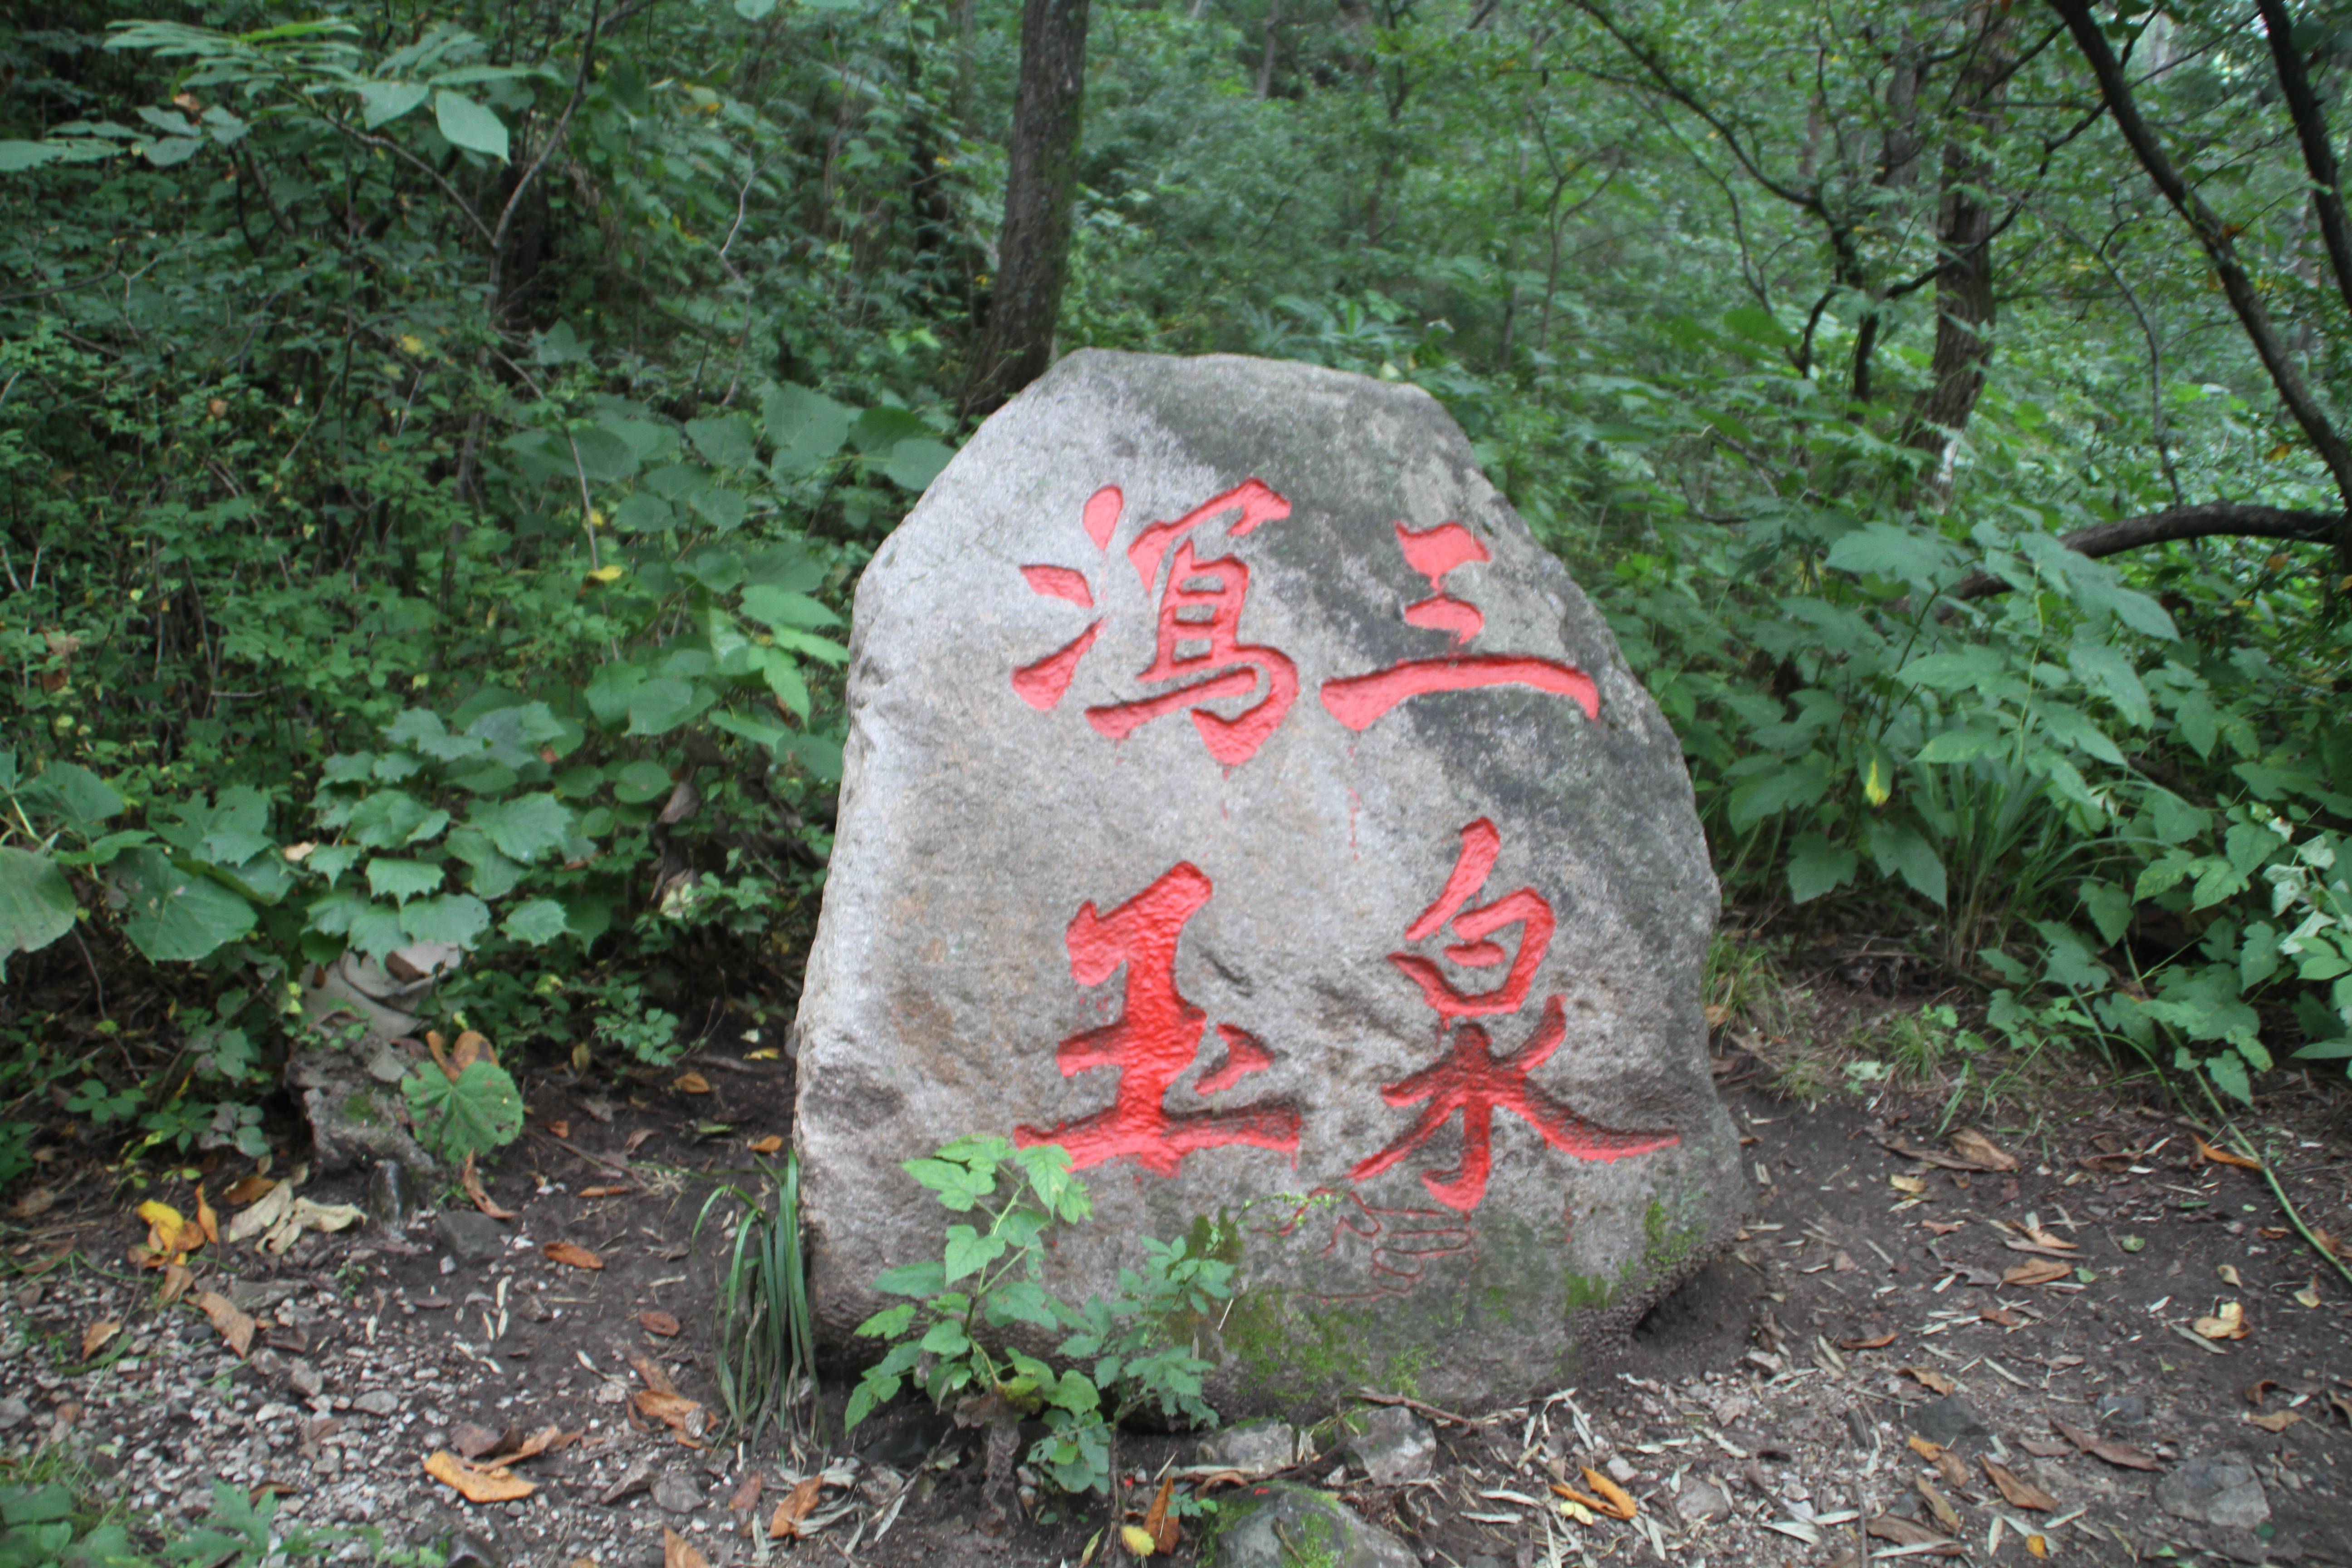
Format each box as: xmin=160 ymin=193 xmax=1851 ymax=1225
xmin=964 ymin=0 xmax=1087 ymax=414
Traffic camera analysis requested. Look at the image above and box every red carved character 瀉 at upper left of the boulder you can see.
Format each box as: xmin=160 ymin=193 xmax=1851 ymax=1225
xmin=1014 ymin=480 xmax=1298 ymax=766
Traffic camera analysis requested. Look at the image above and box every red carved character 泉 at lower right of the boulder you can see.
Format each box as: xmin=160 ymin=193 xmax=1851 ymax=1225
xmin=1352 ymin=818 xmax=1682 ymax=1213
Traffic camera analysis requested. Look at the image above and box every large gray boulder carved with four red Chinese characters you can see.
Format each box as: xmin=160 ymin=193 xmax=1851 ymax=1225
xmin=795 ymin=353 xmax=1745 ymax=1415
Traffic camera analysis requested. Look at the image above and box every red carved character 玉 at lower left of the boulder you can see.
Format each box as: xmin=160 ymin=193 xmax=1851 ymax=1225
xmin=1014 ymin=860 xmax=1301 ymax=1176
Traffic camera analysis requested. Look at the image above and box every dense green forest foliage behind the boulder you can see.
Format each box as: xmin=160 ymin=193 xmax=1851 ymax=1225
xmin=0 ymin=0 xmax=2352 ymax=1180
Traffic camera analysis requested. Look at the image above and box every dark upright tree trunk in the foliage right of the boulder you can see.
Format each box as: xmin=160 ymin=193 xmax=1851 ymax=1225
xmin=1910 ymin=0 xmax=2011 ymax=451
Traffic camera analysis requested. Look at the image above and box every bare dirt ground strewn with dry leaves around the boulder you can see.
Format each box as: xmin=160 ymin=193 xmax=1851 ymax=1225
xmin=0 ymin=1011 xmax=2352 ymax=1568
